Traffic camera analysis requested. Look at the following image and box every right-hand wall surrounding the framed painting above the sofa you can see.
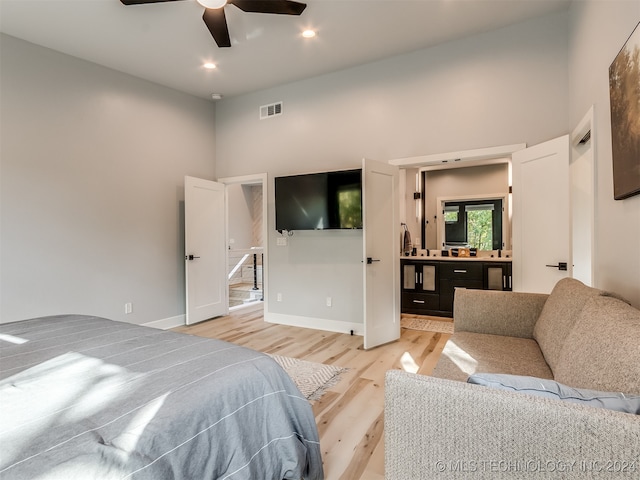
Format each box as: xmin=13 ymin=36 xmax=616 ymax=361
xmin=569 ymin=0 xmax=640 ymax=307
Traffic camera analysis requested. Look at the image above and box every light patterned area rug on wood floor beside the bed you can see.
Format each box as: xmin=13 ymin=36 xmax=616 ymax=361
xmin=271 ymin=355 xmax=349 ymax=402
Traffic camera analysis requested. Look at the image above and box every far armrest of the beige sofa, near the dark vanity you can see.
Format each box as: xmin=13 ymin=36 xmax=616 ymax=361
xmin=453 ymin=288 xmax=549 ymax=338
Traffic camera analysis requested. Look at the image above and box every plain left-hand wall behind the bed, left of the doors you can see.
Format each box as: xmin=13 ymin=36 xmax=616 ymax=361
xmin=0 ymin=35 xmax=215 ymax=324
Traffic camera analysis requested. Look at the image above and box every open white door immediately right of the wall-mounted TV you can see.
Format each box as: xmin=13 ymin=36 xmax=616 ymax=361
xmin=362 ymin=159 xmax=400 ymax=349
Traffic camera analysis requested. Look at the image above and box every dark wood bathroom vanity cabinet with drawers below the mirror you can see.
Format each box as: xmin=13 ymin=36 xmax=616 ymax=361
xmin=400 ymin=257 xmax=511 ymax=317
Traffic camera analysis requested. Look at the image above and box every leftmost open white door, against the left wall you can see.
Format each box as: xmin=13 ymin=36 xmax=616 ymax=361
xmin=184 ymin=177 xmax=229 ymax=325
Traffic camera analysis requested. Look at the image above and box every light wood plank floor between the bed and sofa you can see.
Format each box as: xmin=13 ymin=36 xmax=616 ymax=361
xmin=174 ymin=309 xmax=452 ymax=480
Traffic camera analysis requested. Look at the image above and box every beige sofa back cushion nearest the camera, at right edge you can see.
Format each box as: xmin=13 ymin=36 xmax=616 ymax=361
xmin=554 ymin=297 xmax=640 ymax=395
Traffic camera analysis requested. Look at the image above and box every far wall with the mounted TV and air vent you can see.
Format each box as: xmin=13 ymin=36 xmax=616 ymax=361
xmin=216 ymin=14 xmax=568 ymax=328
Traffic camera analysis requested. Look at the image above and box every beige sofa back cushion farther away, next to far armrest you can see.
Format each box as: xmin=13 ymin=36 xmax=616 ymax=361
xmin=533 ymin=278 xmax=604 ymax=374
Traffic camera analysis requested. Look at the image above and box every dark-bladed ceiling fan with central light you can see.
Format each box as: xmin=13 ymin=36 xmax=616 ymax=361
xmin=120 ymin=0 xmax=307 ymax=47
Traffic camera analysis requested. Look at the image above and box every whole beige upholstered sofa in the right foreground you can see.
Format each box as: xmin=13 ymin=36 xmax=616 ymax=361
xmin=385 ymin=279 xmax=640 ymax=480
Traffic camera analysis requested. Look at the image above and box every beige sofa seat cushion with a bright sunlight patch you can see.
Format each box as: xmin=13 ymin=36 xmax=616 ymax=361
xmin=432 ymin=332 xmax=553 ymax=382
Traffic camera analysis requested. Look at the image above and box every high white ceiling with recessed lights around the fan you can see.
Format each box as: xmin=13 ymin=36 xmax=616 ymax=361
xmin=0 ymin=0 xmax=571 ymax=98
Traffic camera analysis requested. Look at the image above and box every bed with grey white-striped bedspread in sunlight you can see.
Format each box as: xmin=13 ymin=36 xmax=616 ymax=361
xmin=0 ymin=315 xmax=323 ymax=480
